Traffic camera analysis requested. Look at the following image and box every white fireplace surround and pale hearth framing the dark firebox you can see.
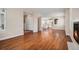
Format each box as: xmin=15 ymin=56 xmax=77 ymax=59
xmin=67 ymin=19 xmax=79 ymax=50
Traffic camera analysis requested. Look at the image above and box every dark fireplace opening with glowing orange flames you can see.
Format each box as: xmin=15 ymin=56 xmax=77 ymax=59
xmin=73 ymin=22 xmax=79 ymax=44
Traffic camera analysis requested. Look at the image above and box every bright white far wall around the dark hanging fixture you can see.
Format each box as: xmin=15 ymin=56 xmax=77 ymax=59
xmin=50 ymin=11 xmax=65 ymax=30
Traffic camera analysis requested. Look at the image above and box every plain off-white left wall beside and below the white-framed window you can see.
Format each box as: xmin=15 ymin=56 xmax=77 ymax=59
xmin=0 ymin=8 xmax=24 ymax=40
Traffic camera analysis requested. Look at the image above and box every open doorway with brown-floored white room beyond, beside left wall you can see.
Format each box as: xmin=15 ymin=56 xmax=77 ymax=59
xmin=24 ymin=15 xmax=33 ymax=34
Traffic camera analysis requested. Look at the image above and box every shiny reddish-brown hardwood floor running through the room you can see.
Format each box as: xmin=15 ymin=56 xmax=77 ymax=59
xmin=0 ymin=29 xmax=68 ymax=50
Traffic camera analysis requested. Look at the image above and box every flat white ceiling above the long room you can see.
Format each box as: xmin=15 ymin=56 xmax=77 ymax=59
xmin=24 ymin=8 xmax=65 ymax=16
